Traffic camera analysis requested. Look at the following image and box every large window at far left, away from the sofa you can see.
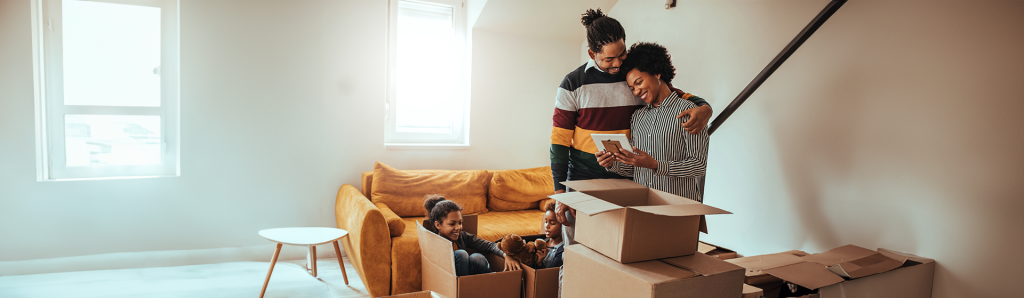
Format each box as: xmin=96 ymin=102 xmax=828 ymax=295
xmin=33 ymin=0 xmax=178 ymax=180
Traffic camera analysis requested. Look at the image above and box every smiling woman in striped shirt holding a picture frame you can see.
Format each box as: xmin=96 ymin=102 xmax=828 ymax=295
xmin=595 ymin=42 xmax=708 ymax=202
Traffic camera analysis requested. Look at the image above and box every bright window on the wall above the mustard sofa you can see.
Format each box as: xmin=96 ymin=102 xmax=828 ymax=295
xmin=385 ymin=0 xmax=469 ymax=145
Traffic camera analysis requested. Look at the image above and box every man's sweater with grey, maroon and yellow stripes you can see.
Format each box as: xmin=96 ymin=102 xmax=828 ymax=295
xmin=551 ymin=60 xmax=708 ymax=190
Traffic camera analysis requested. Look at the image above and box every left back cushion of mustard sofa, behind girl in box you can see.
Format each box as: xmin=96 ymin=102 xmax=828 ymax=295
xmin=370 ymin=162 xmax=490 ymax=217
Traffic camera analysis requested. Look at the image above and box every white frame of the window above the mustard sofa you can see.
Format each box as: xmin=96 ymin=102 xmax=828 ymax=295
xmin=384 ymin=0 xmax=472 ymax=148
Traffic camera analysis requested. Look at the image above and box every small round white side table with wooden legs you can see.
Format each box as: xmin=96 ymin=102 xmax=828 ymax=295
xmin=259 ymin=227 xmax=348 ymax=298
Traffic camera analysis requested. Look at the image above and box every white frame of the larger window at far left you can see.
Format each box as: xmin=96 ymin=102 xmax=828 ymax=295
xmin=32 ymin=0 xmax=180 ymax=181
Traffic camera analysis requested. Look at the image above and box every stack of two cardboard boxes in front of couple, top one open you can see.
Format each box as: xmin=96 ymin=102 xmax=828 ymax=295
xmin=551 ymin=179 xmax=743 ymax=298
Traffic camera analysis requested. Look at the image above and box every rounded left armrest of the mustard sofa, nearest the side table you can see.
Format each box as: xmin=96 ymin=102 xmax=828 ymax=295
xmin=335 ymin=184 xmax=391 ymax=297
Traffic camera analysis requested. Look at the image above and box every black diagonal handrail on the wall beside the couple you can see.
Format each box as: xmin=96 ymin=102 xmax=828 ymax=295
xmin=708 ymin=0 xmax=846 ymax=135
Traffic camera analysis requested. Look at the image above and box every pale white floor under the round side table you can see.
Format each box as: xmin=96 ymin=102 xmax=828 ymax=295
xmin=0 ymin=258 xmax=370 ymax=298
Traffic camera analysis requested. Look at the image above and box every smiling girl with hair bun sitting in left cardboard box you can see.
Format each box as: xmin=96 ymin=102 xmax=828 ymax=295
xmin=423 ymin=195 xmax=519 ymax=276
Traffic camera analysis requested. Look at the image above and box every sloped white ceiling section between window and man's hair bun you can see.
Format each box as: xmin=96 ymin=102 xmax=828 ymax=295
xmin=473 ymin=0 xmax=618 ymax=42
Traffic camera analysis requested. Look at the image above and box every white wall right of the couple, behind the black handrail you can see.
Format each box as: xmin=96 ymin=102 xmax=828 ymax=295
xmin=609 ymin=0 xmax=1024 ymax=298
